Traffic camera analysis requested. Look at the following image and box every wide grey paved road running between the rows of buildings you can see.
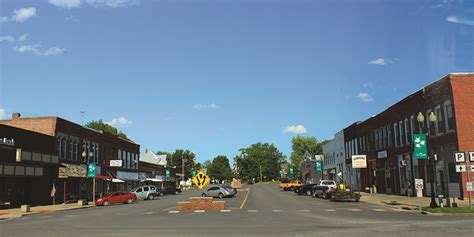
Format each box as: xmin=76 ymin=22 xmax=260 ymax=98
xmin=0 ymin=185 xmax=474 ymax=237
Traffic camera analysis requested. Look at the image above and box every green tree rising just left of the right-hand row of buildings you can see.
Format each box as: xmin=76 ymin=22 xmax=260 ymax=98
xmin=290 ymin=136 xmax=323 ymax=179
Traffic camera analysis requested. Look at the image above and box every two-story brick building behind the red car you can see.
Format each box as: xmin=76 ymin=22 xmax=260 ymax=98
xmin=0 ymin=113 xmax=140 ymax=203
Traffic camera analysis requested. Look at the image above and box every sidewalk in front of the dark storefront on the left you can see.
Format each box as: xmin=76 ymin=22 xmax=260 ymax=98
xmin=0 ymin=203 xmax=95 ymax=220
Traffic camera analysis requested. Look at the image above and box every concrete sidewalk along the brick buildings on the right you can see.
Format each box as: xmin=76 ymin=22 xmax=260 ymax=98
xmin=360 ymin=192 xmax=469 ymax=210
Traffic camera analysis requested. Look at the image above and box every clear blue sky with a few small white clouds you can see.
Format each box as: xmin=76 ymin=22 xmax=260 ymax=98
xmin=0 ymin=0 xmax=474 ymax=161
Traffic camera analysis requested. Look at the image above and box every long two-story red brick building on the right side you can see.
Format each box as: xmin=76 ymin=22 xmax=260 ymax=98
xmin=344 ymin=74 xmax=474 ymax=198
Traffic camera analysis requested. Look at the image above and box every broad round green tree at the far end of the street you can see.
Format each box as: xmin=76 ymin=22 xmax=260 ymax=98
xmin=234 ymin=142 xmax=285 ymax=182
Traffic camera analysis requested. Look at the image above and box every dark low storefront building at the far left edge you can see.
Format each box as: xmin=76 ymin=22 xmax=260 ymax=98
xmin=0 ymin=125 xmax=59 ymax=207
